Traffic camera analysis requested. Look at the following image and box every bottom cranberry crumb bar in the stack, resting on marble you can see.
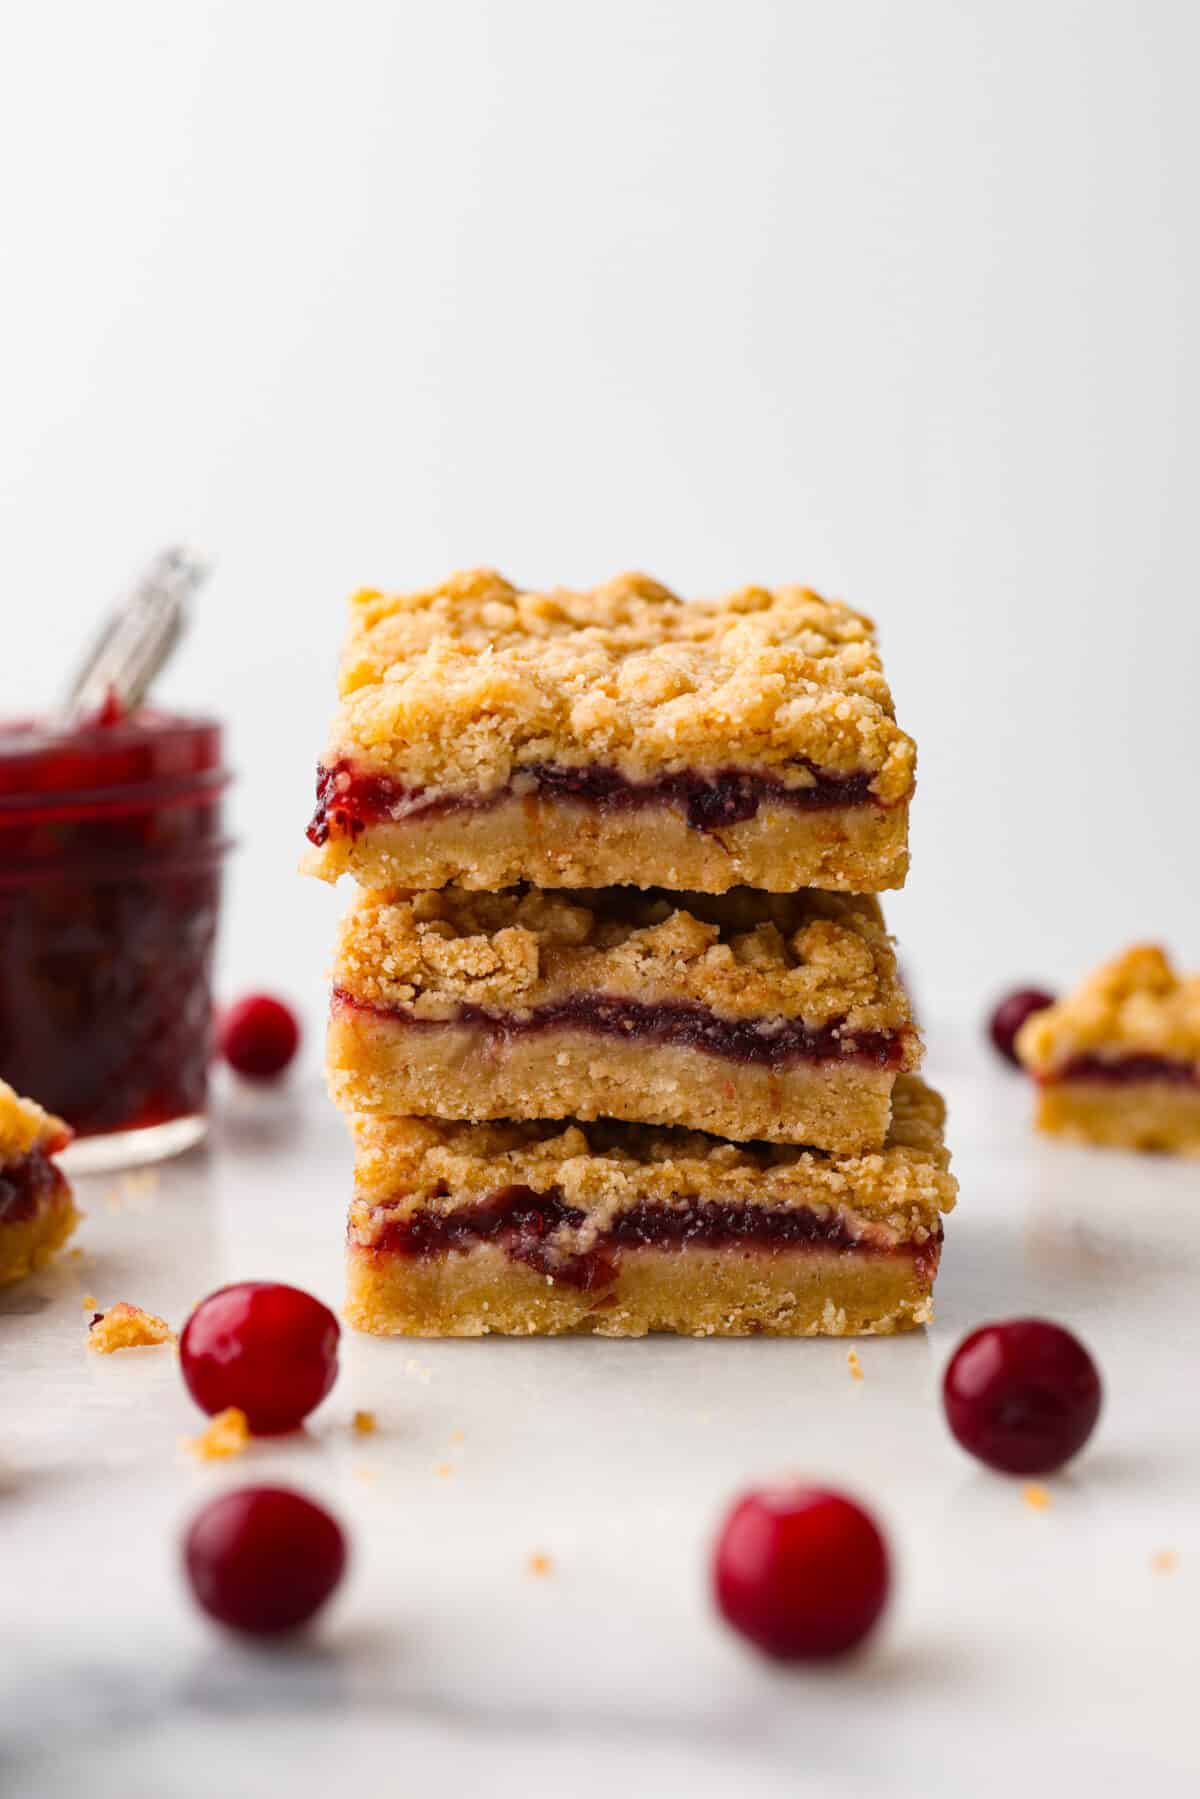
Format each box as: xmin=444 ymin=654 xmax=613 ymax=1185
xmin=347 ymin=1074 xmax=957 ymax=1337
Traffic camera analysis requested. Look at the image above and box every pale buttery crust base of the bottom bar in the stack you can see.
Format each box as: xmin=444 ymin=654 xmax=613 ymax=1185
xmin=345 ymin=1243 xmax=934 ymax=1337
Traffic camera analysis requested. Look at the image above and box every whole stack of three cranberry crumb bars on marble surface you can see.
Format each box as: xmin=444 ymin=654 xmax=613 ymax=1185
xmin=309 ymin=570 xmax=955 ymax=1337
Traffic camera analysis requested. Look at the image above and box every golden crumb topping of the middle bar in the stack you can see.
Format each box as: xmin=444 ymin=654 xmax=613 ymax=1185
xmin=335 ymin=887 xmax=919 ymax=1043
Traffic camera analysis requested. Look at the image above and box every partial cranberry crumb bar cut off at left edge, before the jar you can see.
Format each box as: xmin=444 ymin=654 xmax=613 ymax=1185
xmin=0 ymin=1081 xmax=79 ymax=1286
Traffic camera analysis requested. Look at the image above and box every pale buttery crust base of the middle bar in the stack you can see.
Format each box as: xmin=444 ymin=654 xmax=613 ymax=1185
xmin=326 ymin=1004 xmax=896 ymax=1155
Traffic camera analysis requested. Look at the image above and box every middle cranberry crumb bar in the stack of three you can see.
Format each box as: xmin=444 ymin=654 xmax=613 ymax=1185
xmin=327 ymin=887 xmax=921 ymax=1153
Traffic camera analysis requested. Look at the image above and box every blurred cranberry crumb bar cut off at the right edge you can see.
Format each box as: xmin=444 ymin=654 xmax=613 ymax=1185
xmin=1016 ymin=944 xmax=1200 ymax=1155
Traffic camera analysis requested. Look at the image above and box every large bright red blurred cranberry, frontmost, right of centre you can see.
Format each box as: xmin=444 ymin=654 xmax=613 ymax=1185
xmin=712 ymin=1486 xmax=891 ymax=1662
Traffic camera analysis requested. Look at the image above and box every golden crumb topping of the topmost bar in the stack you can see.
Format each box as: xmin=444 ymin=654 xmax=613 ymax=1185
xmin=326 ymin=570 xmax=916 ymax=802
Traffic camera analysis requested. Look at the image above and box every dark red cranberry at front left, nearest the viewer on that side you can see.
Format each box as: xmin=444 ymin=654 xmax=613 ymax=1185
xmin=184 ymin=1486 xmax=345 ymax=1637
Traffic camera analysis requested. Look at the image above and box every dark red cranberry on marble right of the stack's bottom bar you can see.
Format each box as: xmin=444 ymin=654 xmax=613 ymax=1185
xmin=943 ymin=1319 xmax=1101 ymax=1473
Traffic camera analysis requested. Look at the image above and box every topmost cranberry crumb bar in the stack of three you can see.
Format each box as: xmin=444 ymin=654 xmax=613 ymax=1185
xmin=306 ymin=570 xmax=916 ymax=892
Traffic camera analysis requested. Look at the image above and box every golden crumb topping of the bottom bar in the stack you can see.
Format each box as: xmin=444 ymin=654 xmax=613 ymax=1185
xmin=351 ymin=1074 xmax=957 ymax=1245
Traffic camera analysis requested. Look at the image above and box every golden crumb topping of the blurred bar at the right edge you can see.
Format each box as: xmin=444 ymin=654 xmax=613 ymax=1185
xmin=1016 ymin=943 xmax=1200 ymax=1074
